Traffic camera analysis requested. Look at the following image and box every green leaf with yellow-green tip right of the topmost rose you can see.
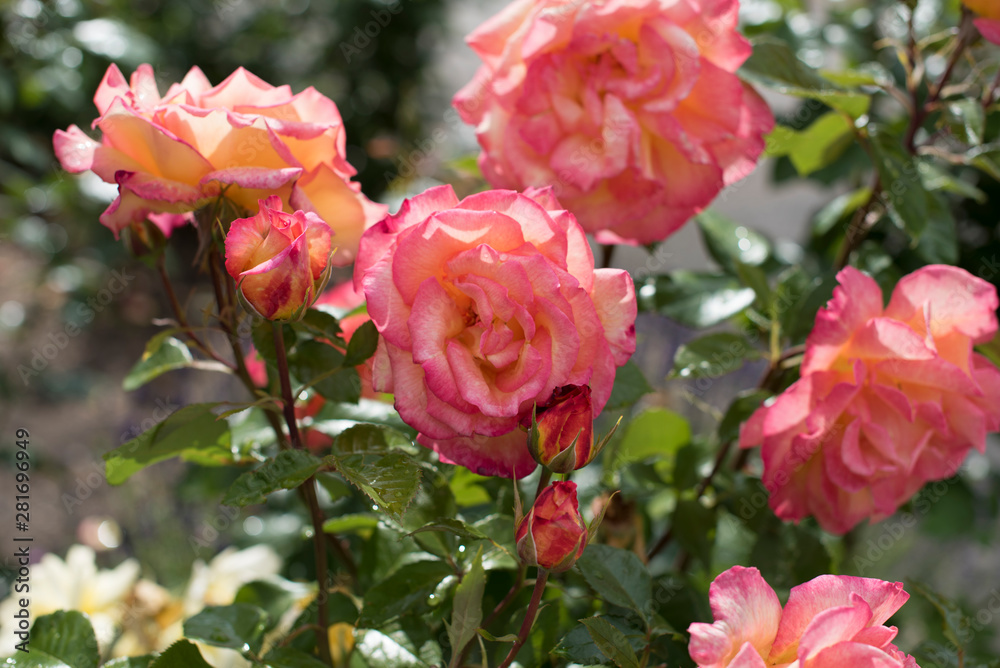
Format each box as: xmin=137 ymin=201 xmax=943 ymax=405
xmin=739 ymin=37 xmax=871 ymax=118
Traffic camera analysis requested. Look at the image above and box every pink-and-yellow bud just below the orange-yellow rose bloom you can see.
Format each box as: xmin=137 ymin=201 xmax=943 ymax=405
xmin=226 ymin=195 xmax=331 ymax=320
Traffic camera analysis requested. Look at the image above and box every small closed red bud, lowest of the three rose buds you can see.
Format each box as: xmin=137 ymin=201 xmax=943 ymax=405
xmin=514 ymin=482 xmax=587 ymax=573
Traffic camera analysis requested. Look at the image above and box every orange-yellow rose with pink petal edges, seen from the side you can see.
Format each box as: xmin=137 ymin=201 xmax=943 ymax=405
xmin=54 ymin=64 xmax=385 ymax=264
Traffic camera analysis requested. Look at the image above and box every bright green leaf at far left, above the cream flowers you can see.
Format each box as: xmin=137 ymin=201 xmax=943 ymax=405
xmin=104 ymin=404 xmax=234 ymax=485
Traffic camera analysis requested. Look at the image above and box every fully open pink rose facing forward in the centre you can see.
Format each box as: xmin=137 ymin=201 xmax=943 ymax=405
xmin=354 ymin=186 xmax=636 ymax=477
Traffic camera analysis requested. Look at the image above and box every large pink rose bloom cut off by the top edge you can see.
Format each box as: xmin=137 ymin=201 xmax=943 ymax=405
xmin=453 ymin=0 xmax=774 ymax=243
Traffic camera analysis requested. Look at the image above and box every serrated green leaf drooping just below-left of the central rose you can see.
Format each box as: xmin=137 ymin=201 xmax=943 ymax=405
xmin=327 ymin=424 xmax=421 ymax=522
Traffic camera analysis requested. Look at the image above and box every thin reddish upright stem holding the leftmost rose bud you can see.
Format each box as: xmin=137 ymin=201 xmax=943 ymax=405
xmin=272 ymin=322 xmax=333 ymax=666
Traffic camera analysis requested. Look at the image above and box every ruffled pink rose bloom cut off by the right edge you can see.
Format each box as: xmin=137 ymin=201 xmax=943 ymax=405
xmin=740 ymin=265 xmax=1000 ymax=533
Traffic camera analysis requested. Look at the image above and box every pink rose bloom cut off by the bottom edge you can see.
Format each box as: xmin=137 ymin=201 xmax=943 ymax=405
xmin=688 ymin=566 xmax=919 ymax=668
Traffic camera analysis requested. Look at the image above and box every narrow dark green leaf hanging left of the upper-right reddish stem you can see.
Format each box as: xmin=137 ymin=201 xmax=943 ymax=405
xmin=868 ymin=125 xmax=930 ymax=241
